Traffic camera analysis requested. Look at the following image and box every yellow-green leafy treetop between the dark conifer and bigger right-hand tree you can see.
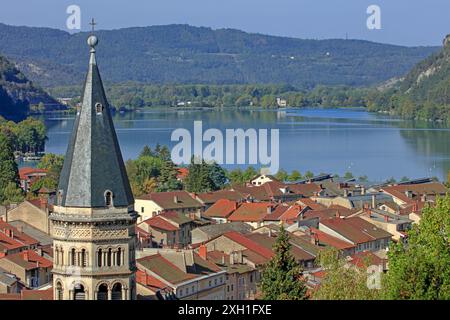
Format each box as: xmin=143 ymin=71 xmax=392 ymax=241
xmin=312 ymin=248 xmax=379 ymax=300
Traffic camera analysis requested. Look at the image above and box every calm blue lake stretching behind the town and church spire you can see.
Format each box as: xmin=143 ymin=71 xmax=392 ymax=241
xmin=38 ymin=108 xmax=450 ymax=181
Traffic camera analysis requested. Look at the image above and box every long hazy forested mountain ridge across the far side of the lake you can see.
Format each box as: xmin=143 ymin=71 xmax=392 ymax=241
xmin=0 ymin=24 xmax=438 ymax=88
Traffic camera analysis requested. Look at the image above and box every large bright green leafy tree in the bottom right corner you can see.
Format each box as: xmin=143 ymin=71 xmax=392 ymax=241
xmin=383 ymin=195 xmax=450 ymax=300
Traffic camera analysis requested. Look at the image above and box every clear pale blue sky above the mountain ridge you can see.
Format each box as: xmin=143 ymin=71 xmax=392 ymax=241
xmin=0 ymin=0 xmax=450 ymax=46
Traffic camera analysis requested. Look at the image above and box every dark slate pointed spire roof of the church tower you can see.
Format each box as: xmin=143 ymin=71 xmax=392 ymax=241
xmin=57 ymin=35 xmax=134 ymax=208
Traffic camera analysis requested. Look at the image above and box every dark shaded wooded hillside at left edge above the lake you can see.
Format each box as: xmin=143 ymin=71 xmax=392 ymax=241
xmin=0 ymin=56 xmax=61 ymax=120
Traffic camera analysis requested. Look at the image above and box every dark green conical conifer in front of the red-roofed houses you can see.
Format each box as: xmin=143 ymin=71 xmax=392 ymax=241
xmin=260 ymin=226 xmax=307 ymax=300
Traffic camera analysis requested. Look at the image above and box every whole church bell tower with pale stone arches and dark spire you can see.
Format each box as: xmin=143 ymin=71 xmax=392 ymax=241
xmin=50 ymin=22 xmax=137 ymax=300
